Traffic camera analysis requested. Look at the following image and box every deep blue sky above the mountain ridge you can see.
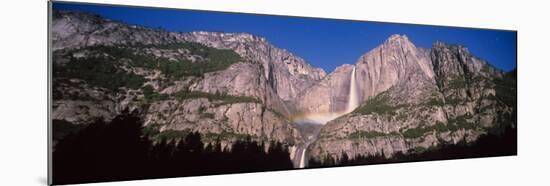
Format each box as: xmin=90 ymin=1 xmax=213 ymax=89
xmin=53 ymin=3 xmax=517 ymax=72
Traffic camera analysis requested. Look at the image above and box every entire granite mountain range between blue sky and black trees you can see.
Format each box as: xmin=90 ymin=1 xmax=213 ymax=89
xmin=52 ymin=12 xmax=515 ymax=165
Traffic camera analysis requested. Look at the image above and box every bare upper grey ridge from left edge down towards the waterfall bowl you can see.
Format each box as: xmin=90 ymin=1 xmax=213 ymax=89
xmin=52 ymin=11 xmax=326 ymax=112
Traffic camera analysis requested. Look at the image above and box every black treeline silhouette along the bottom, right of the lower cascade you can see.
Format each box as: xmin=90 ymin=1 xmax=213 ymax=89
xmin=308 ymin=126 xmax=517 ymax=168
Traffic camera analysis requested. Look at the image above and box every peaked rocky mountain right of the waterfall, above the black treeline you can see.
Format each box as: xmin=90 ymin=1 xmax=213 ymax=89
xmin=308 ymin=35 xmax=512 ymax=160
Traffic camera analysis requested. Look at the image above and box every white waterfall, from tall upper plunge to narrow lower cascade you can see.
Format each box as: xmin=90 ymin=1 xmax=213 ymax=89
xmin=298 ymin=66 xmax=359 ymax=168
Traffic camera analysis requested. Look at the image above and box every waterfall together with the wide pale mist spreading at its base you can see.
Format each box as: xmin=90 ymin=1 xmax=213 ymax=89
xmin=293 ymin=66 xmax=359 ymax=168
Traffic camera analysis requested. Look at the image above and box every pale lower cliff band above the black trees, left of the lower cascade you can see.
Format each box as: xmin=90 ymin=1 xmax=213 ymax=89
xmin=145 ymin=98 xmax=302 ymax=145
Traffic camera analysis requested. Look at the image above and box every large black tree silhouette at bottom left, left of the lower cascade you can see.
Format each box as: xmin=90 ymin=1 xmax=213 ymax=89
xmin=53 ymin=114 xmax=293 ymax=184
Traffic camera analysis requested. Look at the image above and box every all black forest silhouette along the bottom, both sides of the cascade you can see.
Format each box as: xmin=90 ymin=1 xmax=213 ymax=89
xmin=53 ymin=114 xmax=517 ymax=184
